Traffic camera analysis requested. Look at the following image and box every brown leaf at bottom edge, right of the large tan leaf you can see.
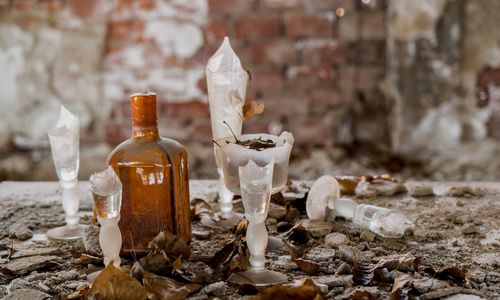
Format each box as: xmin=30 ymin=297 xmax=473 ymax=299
xmin=142 ymin=272 xmax=201 ymax=300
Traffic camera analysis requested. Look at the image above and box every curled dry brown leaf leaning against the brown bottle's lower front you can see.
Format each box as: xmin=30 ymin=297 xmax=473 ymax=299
xmin=148 ymin=230 xmax=191 ymax=258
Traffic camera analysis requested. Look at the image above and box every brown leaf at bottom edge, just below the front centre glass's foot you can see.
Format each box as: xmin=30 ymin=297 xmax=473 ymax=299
xmin=250 ymin=278 xmax=324 ymax=300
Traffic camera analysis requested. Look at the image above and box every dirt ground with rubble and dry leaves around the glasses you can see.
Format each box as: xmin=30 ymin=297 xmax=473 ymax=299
xmin=0 ymin=181 xmax=500 ymax=299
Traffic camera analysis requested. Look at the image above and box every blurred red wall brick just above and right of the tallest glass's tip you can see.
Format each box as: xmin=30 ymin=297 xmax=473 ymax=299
xmin=235 ymin=15 xmax=281 ymax=40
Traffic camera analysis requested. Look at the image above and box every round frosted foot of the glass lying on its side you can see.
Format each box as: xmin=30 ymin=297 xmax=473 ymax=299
xmin=306 ymin=175 xmax=340 ymax=220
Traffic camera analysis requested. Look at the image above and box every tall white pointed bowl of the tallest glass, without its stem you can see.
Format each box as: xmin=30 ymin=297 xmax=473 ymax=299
xmin=205 ymin=37 xmax=248 ymax=140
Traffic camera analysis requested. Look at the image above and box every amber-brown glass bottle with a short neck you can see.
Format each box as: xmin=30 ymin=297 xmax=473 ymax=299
xmin=107 ymin=92 xmax=191 ymax=254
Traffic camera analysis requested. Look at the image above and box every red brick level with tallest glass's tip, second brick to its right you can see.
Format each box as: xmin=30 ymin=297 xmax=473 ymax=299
xmin=299 ymin=39 xmax=346 ymax=65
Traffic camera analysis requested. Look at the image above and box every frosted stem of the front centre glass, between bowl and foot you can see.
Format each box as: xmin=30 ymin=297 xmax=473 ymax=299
xmin=247 ymin=221 xmax=268 ymax=271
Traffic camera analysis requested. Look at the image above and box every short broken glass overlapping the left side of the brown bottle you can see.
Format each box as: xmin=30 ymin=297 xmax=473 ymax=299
xmin=89 ymin=166 xmax=122 ymax=267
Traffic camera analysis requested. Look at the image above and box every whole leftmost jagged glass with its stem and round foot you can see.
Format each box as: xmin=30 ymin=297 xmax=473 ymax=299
xmin=47 ymin=105 xmax=83 ymax=240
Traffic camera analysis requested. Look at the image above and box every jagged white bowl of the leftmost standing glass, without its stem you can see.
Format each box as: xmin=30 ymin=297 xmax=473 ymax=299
xmin=48 ymin=105 xmax=80 ymax=188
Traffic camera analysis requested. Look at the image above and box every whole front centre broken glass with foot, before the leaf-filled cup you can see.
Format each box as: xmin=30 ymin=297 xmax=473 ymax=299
xmin=228 ymin=160 xmax=287 ymax=286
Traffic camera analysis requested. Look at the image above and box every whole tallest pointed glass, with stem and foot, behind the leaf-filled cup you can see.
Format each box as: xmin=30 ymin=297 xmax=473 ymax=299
xmin=202 ymin=37 xmax=248 ymax=228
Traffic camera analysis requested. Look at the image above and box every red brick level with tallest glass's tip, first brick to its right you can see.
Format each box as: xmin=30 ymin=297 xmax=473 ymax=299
xmin=251 ymin=39 xmax=297 ymax=65
